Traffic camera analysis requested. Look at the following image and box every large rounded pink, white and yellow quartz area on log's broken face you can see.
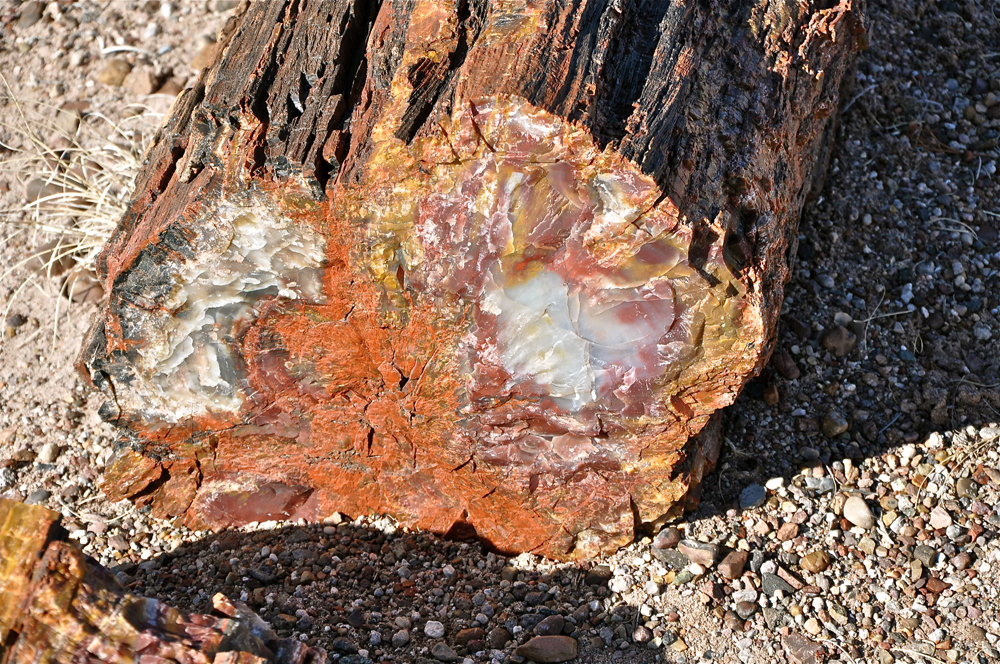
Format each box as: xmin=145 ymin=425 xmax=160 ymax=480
xmin=364 ymin=99 xmax=743 ymax=472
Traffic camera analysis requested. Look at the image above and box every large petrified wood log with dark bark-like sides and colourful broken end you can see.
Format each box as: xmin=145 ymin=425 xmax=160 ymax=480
xmin=82 ymin=0 xmax=865 ymax=557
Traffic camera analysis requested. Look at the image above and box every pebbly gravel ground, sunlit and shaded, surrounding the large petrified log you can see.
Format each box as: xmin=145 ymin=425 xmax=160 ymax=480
xmin=0 ymin=0 xmax=1000 ymax=664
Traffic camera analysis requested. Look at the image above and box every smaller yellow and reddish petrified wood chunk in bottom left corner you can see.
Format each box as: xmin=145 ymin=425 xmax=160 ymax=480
xmin=0 ymin=498 xmax=326 ymax=664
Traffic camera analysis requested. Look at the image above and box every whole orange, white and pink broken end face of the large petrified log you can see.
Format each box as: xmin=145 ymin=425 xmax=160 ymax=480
xmin=92 ymin=98 xmax=743 ymax=556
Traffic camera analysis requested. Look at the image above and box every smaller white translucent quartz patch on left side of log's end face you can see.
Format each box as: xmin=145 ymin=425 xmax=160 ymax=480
xmin=120 ymin=193 xmax=325 ymax=423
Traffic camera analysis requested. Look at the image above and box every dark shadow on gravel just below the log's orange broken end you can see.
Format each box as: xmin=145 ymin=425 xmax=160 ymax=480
xmin=123 ymin=519 xmax=664 ymax=662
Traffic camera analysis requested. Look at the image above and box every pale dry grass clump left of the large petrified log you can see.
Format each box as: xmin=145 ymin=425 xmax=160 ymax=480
xmin=0 ymin=87 xmax=160 ymax=338
